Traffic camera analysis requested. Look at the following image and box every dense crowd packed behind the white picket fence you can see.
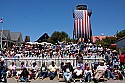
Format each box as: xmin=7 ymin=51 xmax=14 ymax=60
xmin=0 ymin=43 xmax=112 ymax=58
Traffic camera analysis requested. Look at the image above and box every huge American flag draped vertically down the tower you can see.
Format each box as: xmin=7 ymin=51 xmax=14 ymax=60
xmin=74 ymin=10 xmax=92 ymax=40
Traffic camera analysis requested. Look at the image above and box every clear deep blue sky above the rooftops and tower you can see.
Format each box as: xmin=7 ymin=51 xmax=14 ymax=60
xmin=0 ymin=0 xmax=125 ymax=41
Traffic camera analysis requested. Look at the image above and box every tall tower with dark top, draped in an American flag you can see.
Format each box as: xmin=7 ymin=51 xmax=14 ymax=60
xmin=73 ymin=5 xmax=92 ymax=42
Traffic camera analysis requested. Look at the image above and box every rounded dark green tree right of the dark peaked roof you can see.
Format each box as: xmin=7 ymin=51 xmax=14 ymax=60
xmin=48 ymin=31 xmax=71 ymax=44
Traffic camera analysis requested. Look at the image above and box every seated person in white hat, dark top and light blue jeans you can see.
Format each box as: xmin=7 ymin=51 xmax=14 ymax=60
xmin=64 ymin=60 xmax=73 ymax=83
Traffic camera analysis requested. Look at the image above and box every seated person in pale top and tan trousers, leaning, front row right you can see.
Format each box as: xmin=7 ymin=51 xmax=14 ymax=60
xmin=93 ymin=60 xmax=107 ymax=83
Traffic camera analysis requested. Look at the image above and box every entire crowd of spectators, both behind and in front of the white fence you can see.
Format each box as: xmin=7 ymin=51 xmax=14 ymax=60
xmin=0 ymin=42 xmax=125 ymax=83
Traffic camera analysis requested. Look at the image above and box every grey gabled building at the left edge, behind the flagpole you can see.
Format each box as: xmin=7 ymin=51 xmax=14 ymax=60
xmin=0 ymin=30 xmax=23 ymax=48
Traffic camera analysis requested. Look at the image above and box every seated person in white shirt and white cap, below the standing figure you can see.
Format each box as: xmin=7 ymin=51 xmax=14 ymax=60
xmin=73 ymin=65 xmax=83 ymax=82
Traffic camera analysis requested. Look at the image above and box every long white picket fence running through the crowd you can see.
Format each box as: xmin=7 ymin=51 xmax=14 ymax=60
xmin=5 ymin=57 xmax=104 ymax=69
